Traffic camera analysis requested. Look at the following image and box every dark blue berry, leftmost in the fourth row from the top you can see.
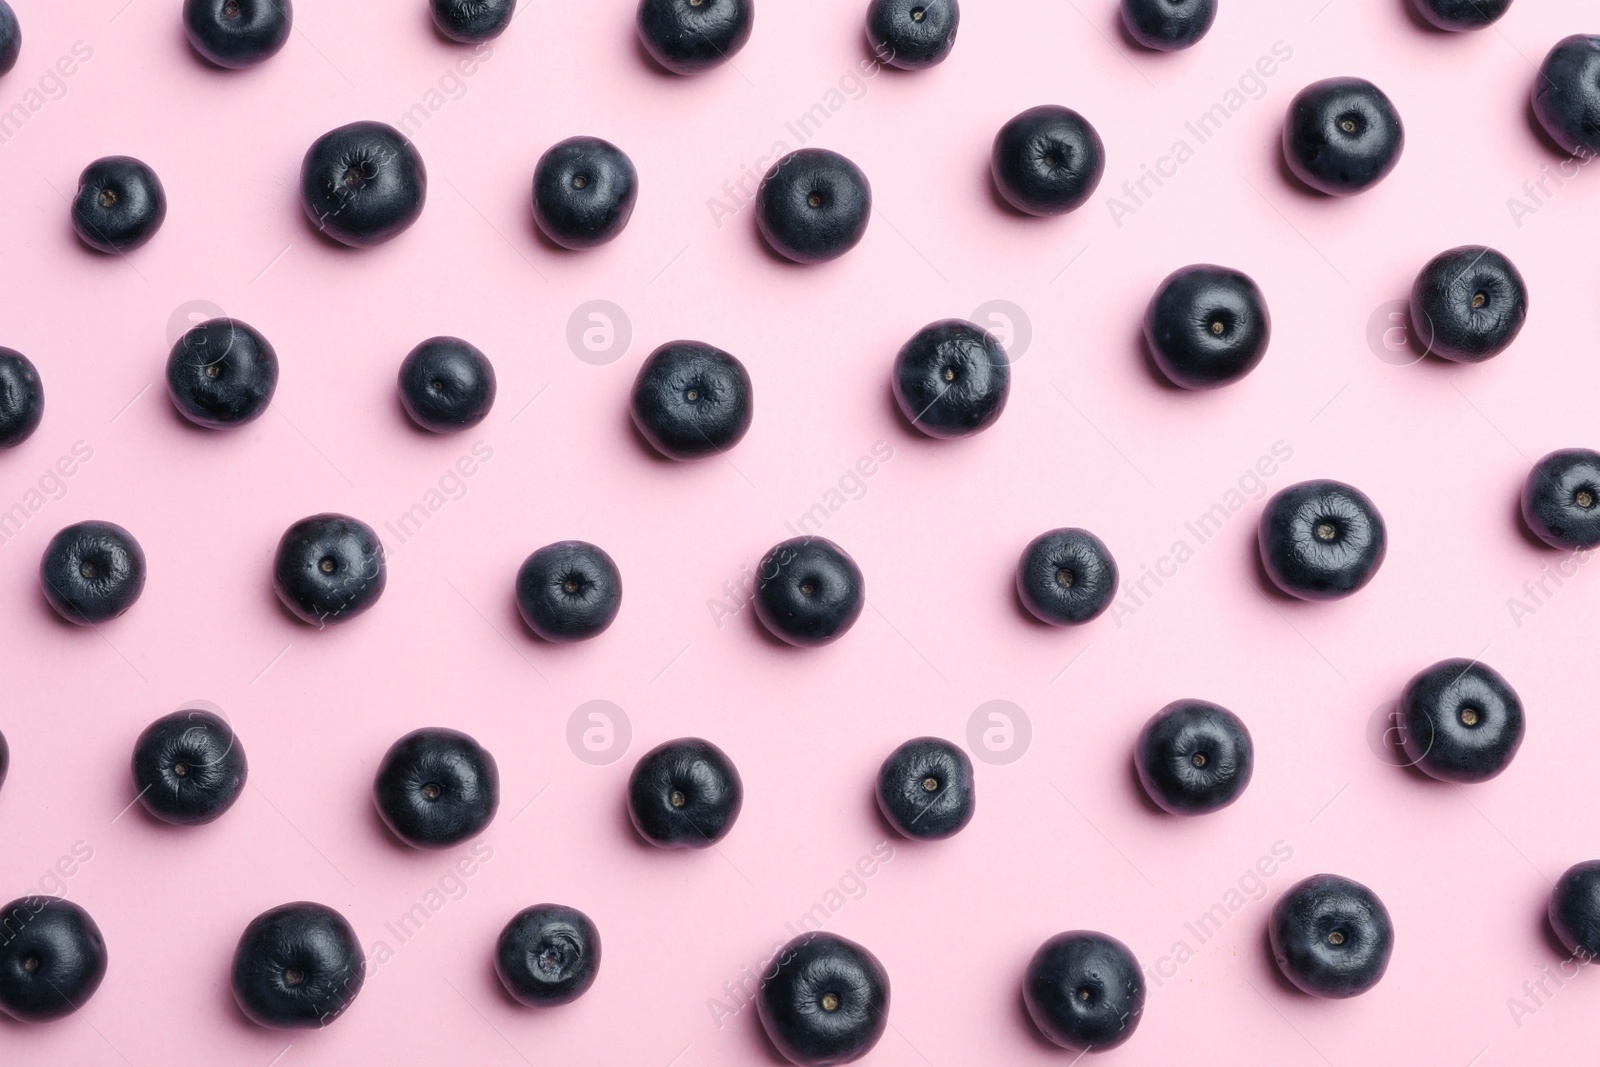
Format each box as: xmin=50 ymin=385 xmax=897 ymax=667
xmin=38 ymin=522 xmax=146 ymax=625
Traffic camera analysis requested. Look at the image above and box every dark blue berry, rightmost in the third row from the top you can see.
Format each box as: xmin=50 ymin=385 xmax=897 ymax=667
xmin=1411 ymin=245 xmax=1528 ymax=363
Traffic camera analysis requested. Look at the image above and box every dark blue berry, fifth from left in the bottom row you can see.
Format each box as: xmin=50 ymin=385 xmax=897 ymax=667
xmin=1022 ymin=929 xmax=1144 ymax=1053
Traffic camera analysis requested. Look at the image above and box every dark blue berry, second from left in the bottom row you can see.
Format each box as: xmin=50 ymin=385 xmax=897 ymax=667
xmin=232 ymin=901 xmax=366 ymax=1030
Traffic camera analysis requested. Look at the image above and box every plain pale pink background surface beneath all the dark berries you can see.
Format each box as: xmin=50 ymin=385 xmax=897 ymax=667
xmin=0 ymin=0 xmax=1600 ymax=1067
